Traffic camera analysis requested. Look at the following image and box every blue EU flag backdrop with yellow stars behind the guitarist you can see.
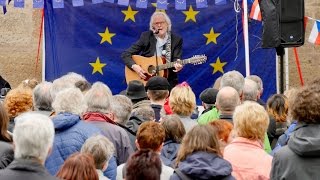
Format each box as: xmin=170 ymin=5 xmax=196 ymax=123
xmin=45 ymin=0 xmax=276 ymax=100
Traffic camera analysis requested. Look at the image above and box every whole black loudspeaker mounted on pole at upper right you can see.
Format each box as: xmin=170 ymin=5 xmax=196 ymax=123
xmin=259 ymin=0 xmax=305 ymax=48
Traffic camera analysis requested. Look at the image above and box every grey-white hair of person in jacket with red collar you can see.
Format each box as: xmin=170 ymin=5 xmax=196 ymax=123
xmin=85 ymin=82 xmax=112 ymax=113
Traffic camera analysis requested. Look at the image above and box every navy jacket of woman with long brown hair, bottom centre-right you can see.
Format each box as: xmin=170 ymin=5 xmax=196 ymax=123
xmin=170 ymin=151 xmax=234 ymax=180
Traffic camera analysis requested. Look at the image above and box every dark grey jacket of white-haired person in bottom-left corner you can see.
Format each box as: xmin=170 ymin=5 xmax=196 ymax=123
xmin=0 ymin=159 xmax=57 ymax=180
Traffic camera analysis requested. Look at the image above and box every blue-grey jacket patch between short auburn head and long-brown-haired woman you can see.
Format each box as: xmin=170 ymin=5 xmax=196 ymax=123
xmin=160 ymin=140 xmax=180 ymax=167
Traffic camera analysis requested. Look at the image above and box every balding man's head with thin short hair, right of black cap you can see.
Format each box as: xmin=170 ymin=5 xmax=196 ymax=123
xmin=216 ymin=86 xmax=241 ymax=123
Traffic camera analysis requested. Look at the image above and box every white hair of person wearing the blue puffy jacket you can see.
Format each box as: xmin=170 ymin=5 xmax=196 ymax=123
xmin=52 ymin=88 xmax=87 ymax=115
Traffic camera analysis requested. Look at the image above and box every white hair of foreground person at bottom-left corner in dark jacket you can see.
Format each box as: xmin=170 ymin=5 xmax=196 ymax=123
xmin=13 ymin=112 xmax=54 ymax=162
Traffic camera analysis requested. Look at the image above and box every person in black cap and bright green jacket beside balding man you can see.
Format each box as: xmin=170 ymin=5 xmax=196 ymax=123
xmin=198 ymin=88 xmax=219 ymax=124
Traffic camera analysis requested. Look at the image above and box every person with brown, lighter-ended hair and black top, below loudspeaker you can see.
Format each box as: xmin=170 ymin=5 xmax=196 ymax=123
xmin=267 ymin=94 xmax=288 ymax=149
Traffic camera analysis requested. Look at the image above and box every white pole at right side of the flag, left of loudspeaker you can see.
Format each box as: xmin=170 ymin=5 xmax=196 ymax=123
xmin=243 ymin=0 xmax=250 ymax=76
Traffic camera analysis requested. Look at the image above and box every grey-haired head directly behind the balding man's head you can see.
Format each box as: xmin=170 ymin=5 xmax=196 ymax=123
xmin=220 ymin=70 xmax=244 ymax=100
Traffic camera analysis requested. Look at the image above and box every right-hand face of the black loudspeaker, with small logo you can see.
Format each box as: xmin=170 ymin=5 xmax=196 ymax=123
xmin=278 ymin=0 xmax=305 ymax=47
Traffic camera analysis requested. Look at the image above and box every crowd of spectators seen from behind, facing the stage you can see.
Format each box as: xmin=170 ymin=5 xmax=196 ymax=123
xmin=0 ymin=71 xmax=320 ymax=180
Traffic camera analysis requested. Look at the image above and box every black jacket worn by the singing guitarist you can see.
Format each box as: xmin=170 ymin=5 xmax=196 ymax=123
xmin=121 ymin=31 xmax=183 ymax=87
